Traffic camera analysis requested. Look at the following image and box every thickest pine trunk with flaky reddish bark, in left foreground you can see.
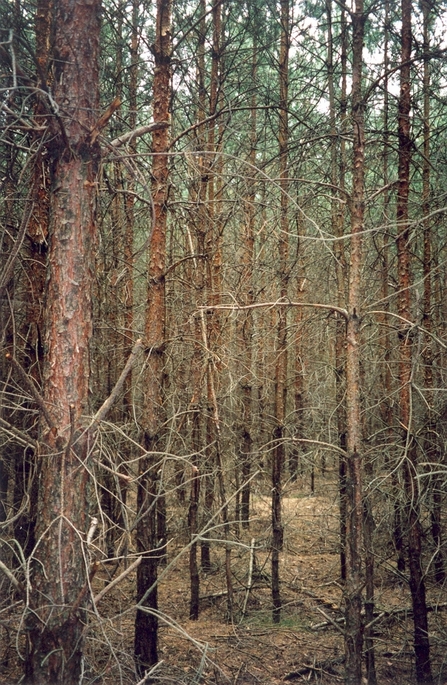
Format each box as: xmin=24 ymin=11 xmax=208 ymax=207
xmin=25 ymin=0 xmax=101 ymax=685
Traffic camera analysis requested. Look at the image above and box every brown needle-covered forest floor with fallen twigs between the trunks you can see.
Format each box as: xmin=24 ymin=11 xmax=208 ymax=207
xmin=0 ymin=474 xmax=447 ymax=685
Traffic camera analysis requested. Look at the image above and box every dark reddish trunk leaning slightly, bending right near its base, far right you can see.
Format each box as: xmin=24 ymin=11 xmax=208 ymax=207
xmin=396 ymin=0 xmax=433 ymax=685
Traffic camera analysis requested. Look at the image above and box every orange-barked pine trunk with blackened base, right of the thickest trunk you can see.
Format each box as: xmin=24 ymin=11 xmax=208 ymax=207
xmin=134 ymin=0 xmax=172 ymax=677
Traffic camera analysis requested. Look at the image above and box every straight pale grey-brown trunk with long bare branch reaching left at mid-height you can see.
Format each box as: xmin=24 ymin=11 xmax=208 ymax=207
xmin=344 ymin=0 xmax=366 ymax=685
